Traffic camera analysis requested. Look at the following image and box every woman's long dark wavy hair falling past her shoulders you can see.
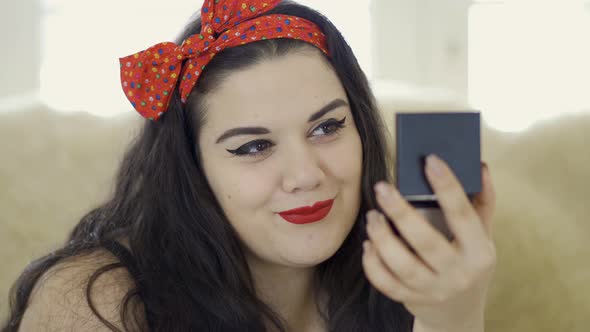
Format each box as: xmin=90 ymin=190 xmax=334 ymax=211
xmin=2 ymin=1 xmax=414 ymax=332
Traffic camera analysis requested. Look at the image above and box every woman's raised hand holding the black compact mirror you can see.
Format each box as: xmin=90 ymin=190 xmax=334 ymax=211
xmin=363 ymin=156 xmax=496 ymax=331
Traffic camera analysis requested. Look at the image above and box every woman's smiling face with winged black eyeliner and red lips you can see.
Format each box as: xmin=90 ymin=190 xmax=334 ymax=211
xmin=199 ymin=49 xmax=363 ymax=267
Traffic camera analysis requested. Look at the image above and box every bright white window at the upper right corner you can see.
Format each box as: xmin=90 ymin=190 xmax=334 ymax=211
xmin=468 ymin=0 xmax=590 ymax=131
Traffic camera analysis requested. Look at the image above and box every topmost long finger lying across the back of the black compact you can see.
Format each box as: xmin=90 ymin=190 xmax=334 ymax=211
xmin=426 ymin=155 xmax=487 ymax=249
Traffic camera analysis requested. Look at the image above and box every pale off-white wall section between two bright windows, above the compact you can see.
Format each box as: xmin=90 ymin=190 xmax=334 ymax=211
xmin=371 ymin=0 xmax=471 ymax=99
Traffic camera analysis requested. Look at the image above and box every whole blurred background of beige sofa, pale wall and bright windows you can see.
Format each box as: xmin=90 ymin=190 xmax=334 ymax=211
xmin=0 ymin=0 xmax=590 ymax=332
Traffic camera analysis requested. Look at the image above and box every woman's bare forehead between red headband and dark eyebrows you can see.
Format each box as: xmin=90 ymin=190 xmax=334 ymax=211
xmin=202 ymin=52 xmax=346 ymax=130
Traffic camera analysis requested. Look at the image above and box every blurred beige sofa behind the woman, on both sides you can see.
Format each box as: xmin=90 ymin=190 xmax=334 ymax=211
xmin=0 ymin=99 xmax=590 ymax=332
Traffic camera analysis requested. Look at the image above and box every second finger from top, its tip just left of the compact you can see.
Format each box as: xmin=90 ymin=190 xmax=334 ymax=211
xmin=376 ymin=182 xmax=457 ymax=272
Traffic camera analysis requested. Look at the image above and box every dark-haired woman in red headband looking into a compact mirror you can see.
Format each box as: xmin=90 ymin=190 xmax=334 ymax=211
xmin=2 ymin=0 xmax=495 ymax=332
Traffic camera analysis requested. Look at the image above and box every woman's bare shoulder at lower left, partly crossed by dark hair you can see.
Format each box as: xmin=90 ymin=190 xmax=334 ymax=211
xmin=19 ymin=244 xmax=145 ymax=331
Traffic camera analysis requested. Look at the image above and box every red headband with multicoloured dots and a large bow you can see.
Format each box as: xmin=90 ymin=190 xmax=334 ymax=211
xmin=119 ymin=0 xmax=329 ymax=120
